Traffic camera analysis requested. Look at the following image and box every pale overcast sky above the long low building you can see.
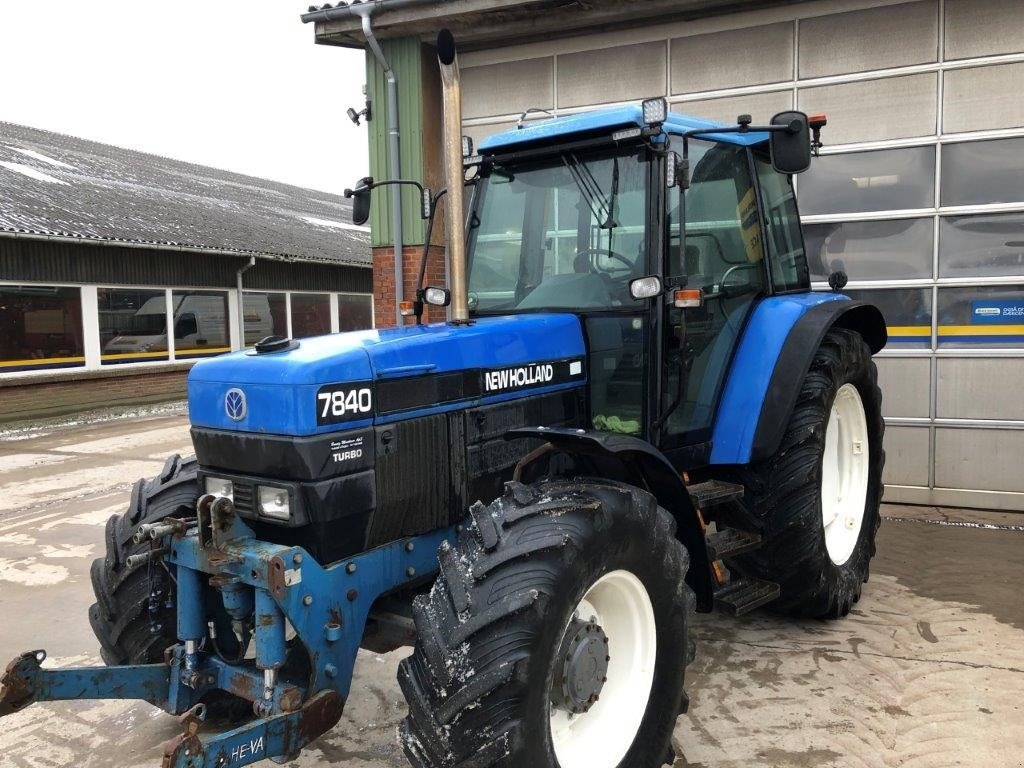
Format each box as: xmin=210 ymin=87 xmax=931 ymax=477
xmin=0 ymin=0 xmax=367 ymax=193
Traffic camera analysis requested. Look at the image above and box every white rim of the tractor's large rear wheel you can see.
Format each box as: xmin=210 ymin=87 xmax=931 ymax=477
xmin=821 ymin=384 xmax=869 ymax=565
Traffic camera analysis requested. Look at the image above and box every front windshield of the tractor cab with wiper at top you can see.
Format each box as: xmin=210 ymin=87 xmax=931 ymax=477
xmin=469 ymin=144 xmax=648 ymax=312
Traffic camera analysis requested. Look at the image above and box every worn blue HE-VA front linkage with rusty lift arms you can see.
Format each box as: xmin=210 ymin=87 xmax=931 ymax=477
xmin=0 ymin=496 xmax=455 ymax=768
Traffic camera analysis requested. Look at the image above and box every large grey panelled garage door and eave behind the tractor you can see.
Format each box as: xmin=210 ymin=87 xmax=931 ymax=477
xmin=309 ymin=0 xmax=1024 ymax=518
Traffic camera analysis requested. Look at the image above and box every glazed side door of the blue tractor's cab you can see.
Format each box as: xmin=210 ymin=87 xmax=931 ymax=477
xmin=659 ymin=140 xmax=766 ymax=459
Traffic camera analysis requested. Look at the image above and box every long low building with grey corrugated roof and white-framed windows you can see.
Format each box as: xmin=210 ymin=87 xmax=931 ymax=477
xmin=0 ymin=123 xmax=374 ymax=421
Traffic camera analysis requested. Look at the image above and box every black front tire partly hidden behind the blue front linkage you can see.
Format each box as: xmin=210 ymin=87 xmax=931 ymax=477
xmin=89 ymin=454 xmax=253 ymax=722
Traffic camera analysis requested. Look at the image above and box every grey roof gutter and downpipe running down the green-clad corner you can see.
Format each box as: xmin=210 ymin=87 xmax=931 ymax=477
xmin=302 ymin=0 xmax=411 ymax=326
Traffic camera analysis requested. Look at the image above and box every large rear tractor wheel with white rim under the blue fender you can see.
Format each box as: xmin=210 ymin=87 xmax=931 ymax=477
xmin=724 ymin=328 xmax=886 ymax=618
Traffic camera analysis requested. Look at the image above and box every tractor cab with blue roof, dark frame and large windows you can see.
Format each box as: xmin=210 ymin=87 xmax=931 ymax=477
xmin=467 ymin=99 xmax=811 ymax=464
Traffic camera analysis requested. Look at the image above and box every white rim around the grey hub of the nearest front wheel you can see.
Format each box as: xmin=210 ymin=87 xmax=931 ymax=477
xmin=551 ymin=570 xmax=657 ymax=768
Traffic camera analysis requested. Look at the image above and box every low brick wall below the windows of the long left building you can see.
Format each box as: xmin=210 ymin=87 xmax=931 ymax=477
xmin=0 ymin=362 xmax=191 ymax=423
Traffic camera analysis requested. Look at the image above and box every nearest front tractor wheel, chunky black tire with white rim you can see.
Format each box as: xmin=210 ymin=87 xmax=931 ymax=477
xmin=398 ymin=479 xmax=693 ymax=768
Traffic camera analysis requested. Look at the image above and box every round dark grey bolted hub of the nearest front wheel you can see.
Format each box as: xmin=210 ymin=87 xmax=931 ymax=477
xmin=551 ymin=616 xmax=611 ymax=715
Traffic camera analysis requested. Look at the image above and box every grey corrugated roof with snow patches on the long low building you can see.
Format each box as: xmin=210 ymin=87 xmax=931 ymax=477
xmin=0 ymin=122 xmax=372 ymax=266
